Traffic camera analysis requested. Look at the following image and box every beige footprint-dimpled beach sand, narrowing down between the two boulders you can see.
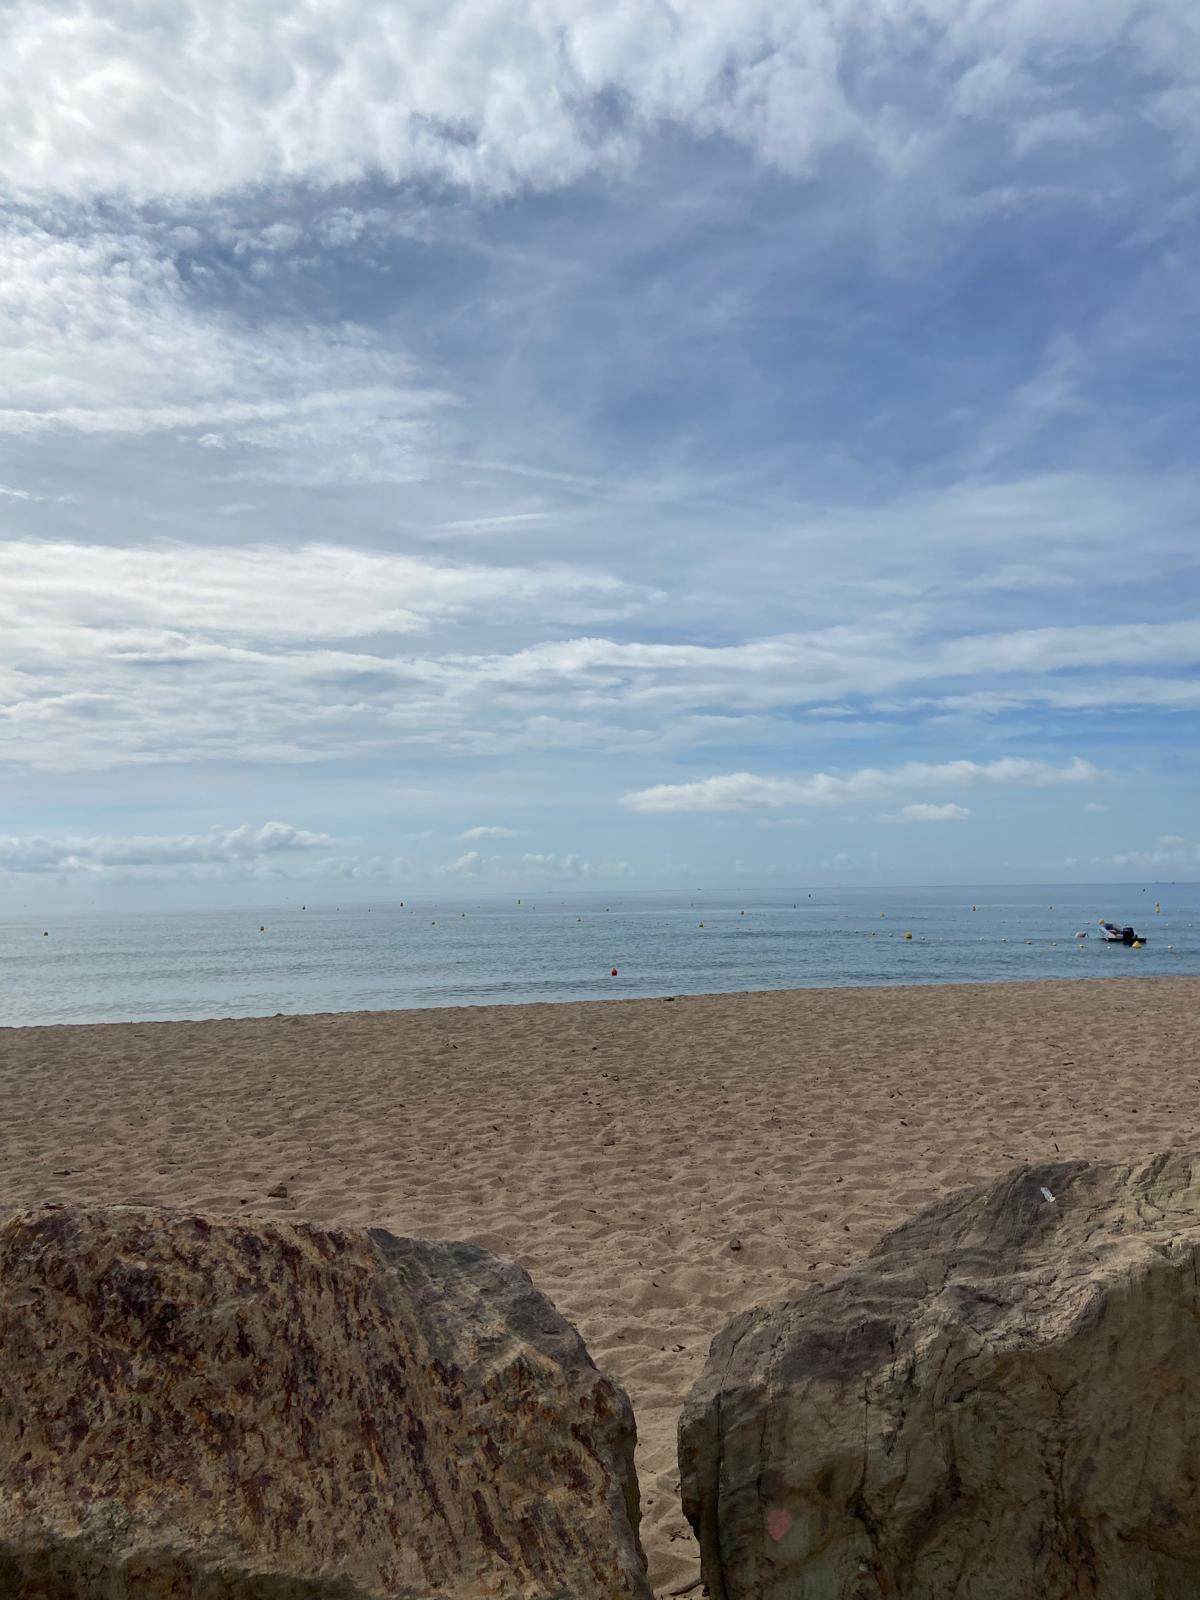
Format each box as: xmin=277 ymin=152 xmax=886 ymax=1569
xmin=0 ymin=978 xmax=1200 ymax=1590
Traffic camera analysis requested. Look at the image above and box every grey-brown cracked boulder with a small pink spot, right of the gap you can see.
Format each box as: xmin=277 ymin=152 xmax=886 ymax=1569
xmin=680 ymin=1154 xmax=1200 ymax=1600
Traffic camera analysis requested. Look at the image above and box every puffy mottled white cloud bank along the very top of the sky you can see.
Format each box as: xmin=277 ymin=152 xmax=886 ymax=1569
xmin=0 ymin=0 xmax=1197 ymax=203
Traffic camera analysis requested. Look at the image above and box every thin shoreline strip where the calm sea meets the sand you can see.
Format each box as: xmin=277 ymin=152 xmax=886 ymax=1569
xmin=0 ymin=973 xmax=1200 ymax=1038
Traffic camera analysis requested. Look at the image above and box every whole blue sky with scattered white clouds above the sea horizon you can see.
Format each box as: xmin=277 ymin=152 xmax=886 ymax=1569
xmin=0 ymin=0 xmax=1200 ymax=915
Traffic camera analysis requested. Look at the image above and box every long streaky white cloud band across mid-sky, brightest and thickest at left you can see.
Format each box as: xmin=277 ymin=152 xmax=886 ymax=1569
xmin=11 ymin=539 xmax=1200 ymax=774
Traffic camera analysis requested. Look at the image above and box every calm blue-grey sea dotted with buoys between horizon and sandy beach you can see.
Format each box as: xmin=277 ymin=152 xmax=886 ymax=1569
xmin=0 ymin=883 xmax=1200 ymax=1026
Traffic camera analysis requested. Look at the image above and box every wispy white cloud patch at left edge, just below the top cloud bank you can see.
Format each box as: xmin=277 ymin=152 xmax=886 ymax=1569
xmin=0 ymin=214 xmax=448 ymax=448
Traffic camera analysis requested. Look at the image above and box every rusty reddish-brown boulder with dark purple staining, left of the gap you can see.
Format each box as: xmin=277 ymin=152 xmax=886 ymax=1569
xmin=0 ymin=1206 xmax=650 ymax=1600
